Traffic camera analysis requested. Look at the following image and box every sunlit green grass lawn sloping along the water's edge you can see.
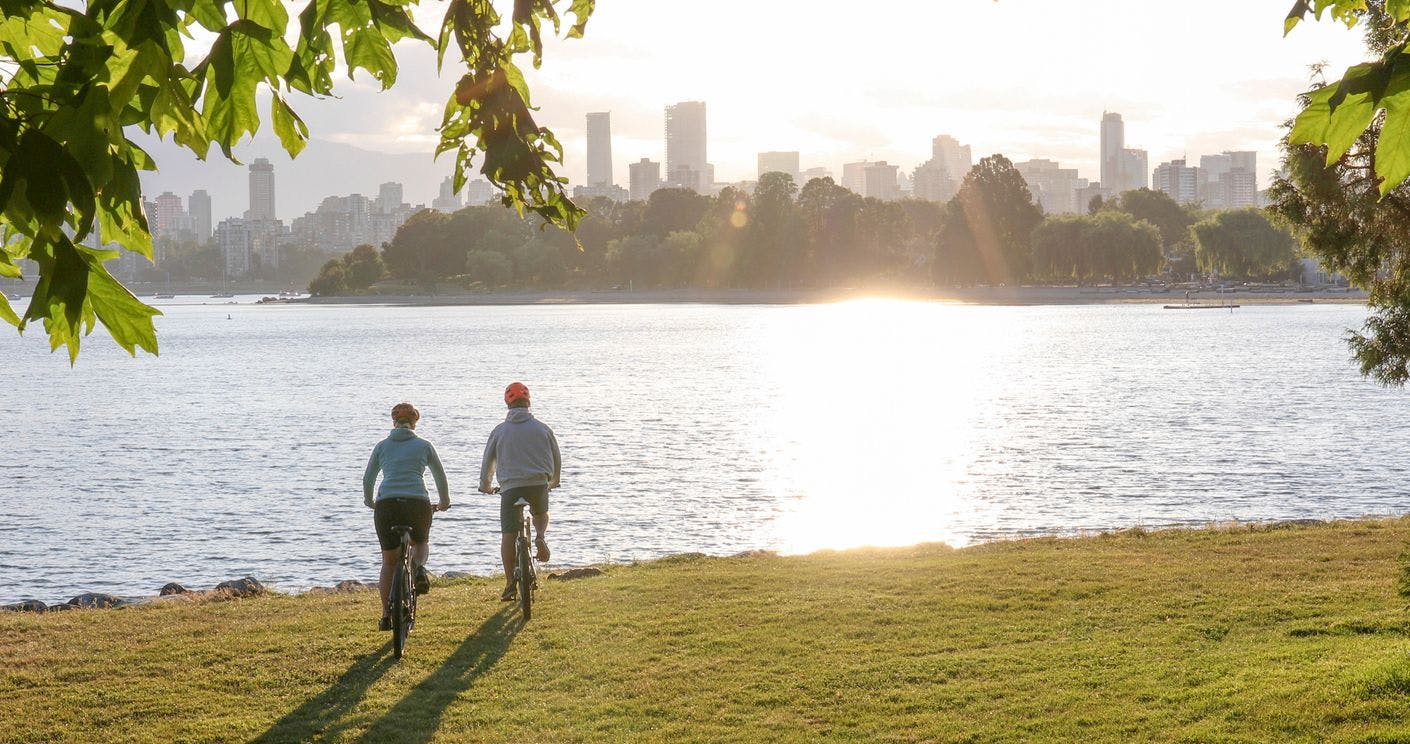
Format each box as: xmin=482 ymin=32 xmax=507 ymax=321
xmin=8 ymin=520 xmax=1410 ymax=743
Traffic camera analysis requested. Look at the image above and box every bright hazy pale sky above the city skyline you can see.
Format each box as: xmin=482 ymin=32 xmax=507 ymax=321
xmin=145 ymin=0 xmax=1363 ymax=215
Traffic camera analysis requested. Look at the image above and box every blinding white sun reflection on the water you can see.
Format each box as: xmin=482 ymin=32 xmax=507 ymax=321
xmin=763 ymin=299 xmax=990 ymax=552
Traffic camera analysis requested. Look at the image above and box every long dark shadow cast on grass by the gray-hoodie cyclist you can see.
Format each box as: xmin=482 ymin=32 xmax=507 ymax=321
xmin=358 ymin=607 xmax=520 ymax=743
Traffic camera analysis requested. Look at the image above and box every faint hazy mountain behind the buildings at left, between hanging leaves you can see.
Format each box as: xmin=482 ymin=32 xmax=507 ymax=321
xmin=137 ymin=137 xmax=454 ymax=224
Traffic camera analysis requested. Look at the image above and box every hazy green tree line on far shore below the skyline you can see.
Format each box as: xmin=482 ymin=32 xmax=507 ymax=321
xmin=309 ymin=155 xmax=1301 ymax=296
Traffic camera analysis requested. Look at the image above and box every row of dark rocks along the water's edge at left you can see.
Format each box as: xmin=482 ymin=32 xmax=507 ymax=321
xmin=0 ymin=566 xmax=602 ymax=613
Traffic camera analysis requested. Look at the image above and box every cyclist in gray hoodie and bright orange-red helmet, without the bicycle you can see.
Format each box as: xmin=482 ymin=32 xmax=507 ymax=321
xmin=479 ymin=382 xmax=563 ymax=602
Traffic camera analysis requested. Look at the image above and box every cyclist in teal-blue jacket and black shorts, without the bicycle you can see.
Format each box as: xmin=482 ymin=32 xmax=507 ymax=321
xmin=362 ymin=403 xmax=450 ymax=630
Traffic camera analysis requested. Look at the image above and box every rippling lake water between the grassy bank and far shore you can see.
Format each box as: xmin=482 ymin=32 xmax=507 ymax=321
xmin=0 ymin=299 xmax=1410 ymax=602
